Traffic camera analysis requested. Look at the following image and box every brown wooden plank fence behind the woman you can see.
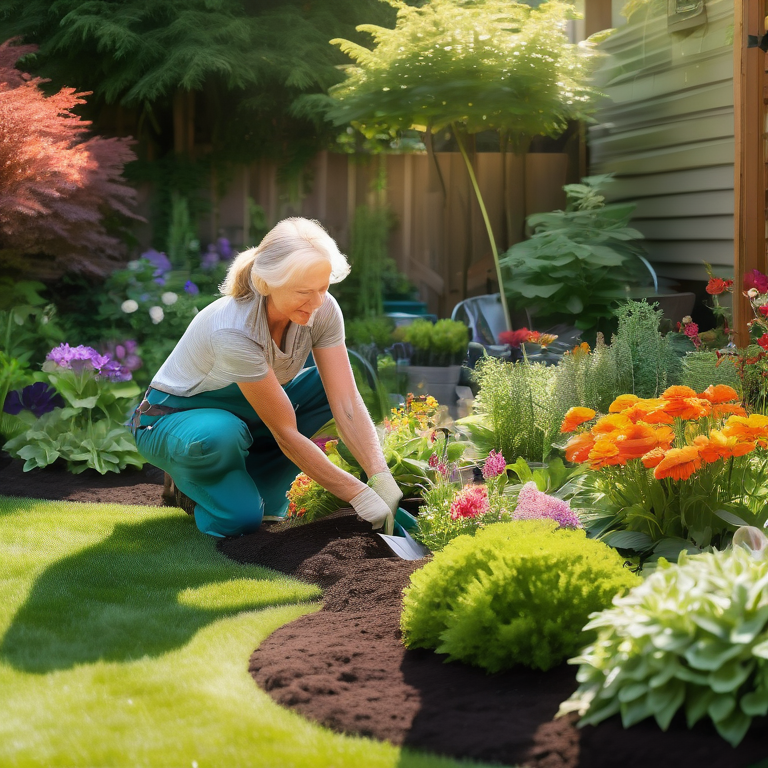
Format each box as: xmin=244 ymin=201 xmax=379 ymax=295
xmin=192 ymin=152 xmax=579 ymax=317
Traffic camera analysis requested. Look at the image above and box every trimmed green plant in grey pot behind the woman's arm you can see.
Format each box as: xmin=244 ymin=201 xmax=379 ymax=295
xmin=404 ymin=319 xmax=469 ymax=406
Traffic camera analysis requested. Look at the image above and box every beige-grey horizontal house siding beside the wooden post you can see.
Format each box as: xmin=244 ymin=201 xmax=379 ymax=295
xmin=590 ymin=0 xmax=734 ymax=280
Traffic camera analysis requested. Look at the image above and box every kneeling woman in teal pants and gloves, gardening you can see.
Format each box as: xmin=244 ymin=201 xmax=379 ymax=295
xmin=133 ymin=218 xmax=402 ymax=536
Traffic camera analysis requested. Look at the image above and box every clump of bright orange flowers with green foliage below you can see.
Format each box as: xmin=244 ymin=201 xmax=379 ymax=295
xmin=561 ymin=385 xmax=768 ymax=558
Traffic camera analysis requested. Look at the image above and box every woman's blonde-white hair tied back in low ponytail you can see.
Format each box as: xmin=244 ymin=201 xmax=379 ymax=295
xmin=219 ymin=216 xmax=350 ymax=299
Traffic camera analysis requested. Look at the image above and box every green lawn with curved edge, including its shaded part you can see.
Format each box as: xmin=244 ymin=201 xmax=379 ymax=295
xmin=0 ymin=497 xmax=488 ymax=768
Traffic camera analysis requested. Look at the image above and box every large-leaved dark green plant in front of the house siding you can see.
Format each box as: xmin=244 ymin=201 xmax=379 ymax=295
xmin=501 ymin=176 xmax=648 ymax=334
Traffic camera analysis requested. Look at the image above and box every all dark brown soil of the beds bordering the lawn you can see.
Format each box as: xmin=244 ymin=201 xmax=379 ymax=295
xmin=0 ymin=462 xmax=768 ymax=768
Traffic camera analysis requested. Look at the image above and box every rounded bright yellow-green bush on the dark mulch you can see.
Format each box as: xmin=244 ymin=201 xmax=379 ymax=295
xmin=401 ymin=520 xmax=639 ymax=672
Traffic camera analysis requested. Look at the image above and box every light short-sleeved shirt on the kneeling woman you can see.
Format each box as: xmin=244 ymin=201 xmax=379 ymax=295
xmin=150 ymin=293 xmax=344 ymax=397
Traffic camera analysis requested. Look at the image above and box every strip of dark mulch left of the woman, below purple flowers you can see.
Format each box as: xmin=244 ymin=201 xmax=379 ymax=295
xmin=0 ymin=452 xmax=163 ymax=507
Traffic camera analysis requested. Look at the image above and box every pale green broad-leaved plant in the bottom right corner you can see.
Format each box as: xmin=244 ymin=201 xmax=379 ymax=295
xmin=559 ymin=546 xmax=768 ymax=746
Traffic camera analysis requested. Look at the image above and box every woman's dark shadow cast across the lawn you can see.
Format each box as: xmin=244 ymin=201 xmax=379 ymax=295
xmin=0 ymin=517 xmax=317 ymax=673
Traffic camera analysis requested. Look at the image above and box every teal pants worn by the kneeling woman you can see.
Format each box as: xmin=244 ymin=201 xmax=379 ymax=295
xmin=136 ymin=368 xmax=331 ymax=536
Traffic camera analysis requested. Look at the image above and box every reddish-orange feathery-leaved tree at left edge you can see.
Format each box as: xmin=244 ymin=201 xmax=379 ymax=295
xmin=0 ymin=41 xmax=139 ymax=275
